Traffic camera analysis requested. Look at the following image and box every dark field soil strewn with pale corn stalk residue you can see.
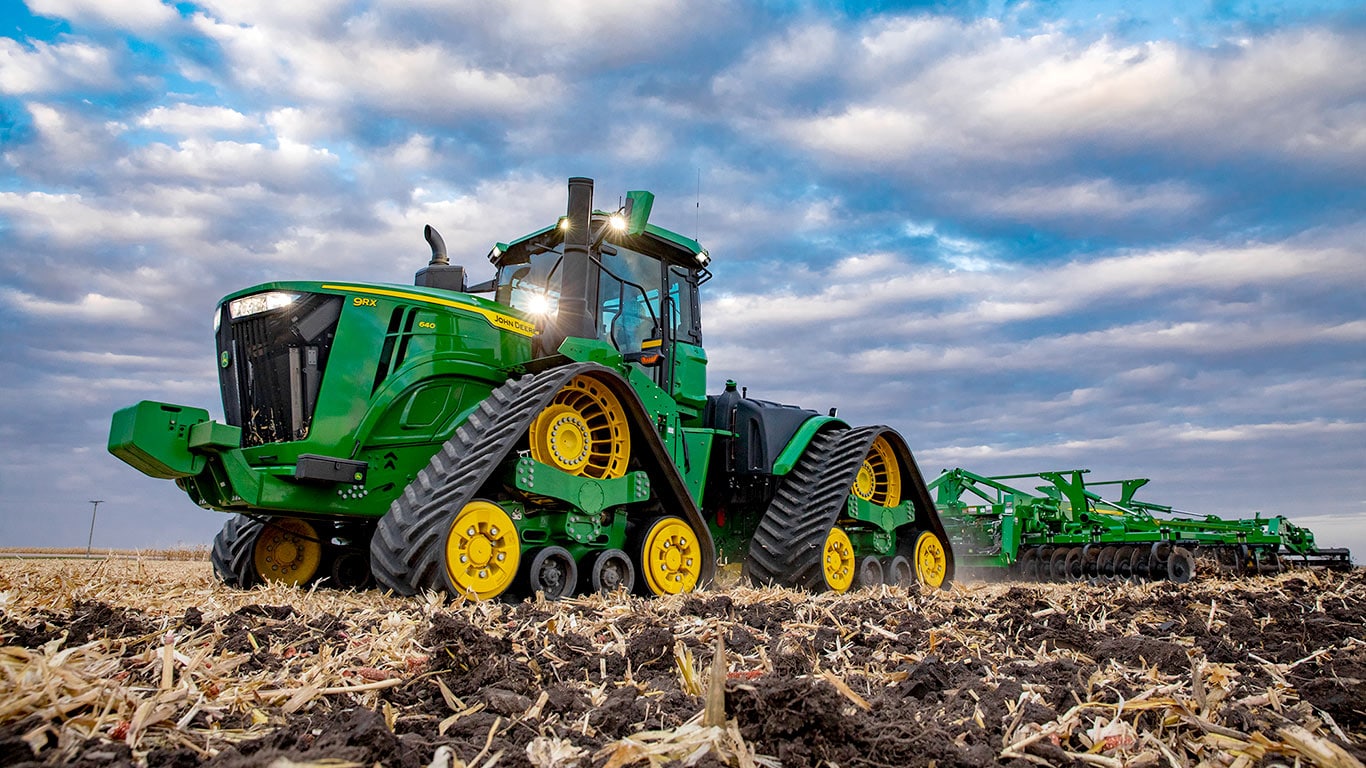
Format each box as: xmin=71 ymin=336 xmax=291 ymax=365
xmin=0 ymin=560 xmax=1366 ymax=768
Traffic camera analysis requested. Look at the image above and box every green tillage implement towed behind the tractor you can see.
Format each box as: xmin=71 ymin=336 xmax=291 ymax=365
xmin=929 ymin=469 xmax=1351 ymax=582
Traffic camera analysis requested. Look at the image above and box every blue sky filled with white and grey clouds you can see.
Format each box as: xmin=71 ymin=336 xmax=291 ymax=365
xmin=0 ymin=0 xmax=1366 ymax=562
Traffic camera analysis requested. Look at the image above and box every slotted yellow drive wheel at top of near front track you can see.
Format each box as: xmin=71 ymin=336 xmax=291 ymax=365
xmin=527 ymin=376 xmax=631 ymax=480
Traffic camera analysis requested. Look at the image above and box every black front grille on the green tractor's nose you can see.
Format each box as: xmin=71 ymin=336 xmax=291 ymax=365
xmin=219 ymin=294 xmax=342 ymax=447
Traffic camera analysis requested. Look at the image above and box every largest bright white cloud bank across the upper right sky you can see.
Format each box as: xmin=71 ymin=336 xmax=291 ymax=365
xmin=744 ymin=19 xmax=1366 ymax=168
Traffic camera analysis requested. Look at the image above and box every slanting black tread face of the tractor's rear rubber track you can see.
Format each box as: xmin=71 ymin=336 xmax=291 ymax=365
xmin=746 ymin=426 xmax=887 ymax=590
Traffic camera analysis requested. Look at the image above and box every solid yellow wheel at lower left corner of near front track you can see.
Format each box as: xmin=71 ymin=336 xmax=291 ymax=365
xmin=445 ymin=499 xmax=522 ymax=600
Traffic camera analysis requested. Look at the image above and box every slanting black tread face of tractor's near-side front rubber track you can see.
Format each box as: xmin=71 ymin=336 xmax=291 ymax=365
xmin=370 ymin=365 xmax=583 ymax=596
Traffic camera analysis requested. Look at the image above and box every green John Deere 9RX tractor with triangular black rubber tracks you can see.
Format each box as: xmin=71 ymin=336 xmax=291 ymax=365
xmin=109 ymin=178 xmax=953 ymax=599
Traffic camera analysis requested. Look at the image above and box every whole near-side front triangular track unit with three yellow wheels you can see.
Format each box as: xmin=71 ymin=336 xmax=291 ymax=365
xmin=370 ymin=364 xmax=716 ymax=600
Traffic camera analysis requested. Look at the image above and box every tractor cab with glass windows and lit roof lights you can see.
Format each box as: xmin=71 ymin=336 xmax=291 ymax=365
xmin=489 ymin=180 xmax=710 ymax=415
